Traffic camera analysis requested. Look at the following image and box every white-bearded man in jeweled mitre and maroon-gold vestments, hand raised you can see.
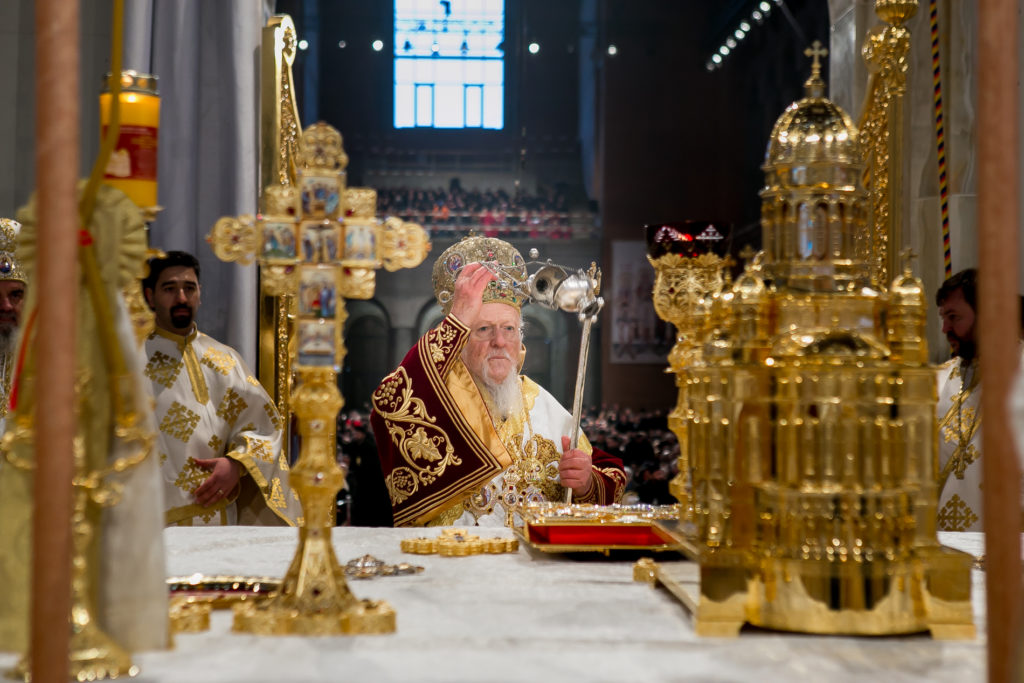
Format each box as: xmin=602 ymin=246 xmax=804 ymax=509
xmin=371 ymin=237 xmax=626 ymax=526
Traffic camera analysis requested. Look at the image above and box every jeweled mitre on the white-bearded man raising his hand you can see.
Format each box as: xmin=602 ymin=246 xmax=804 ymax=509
xmin=433 ymin=237 xmax=529 ymax=315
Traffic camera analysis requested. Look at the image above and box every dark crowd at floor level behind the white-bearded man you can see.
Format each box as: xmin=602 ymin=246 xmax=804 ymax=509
xmin=337 ymin=405 xmax=679 ymax=526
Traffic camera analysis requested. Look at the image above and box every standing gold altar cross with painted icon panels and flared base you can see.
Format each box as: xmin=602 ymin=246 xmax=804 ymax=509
xmin=207 ymin=118 xmax=430 ymax=635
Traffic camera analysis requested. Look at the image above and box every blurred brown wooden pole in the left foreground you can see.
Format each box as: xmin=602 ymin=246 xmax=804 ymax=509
xmin=30 ymin=0 xmax=81 ymax=683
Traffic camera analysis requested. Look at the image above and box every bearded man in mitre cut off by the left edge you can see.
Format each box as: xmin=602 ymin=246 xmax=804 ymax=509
xmin=0 ymin=218 xmax=26 ymax=435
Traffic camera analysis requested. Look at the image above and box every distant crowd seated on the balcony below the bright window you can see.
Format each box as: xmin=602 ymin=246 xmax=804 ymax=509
xmin=377 ymin=179 xmax=593 ymax=240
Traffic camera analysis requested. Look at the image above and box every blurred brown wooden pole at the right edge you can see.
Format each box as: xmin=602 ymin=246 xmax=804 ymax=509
xmin=976 ymin=0 xmax=1021 ymax=682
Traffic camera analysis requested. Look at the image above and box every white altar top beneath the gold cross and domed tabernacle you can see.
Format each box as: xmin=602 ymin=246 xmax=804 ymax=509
xmin=0 ymin=526 xmax=986 ymax=683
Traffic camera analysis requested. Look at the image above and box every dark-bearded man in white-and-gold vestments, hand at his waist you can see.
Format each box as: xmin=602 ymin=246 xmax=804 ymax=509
xmin=142 ymin=251 xmax=300 ymax=526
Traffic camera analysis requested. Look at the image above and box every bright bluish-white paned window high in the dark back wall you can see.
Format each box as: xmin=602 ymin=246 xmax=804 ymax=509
xmin=394 ymin=0 xmax=505 ymax=129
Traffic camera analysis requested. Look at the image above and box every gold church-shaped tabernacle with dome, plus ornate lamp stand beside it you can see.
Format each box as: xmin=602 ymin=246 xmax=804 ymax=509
xmin=636 ymin=46 xmax=975 ymax=638
